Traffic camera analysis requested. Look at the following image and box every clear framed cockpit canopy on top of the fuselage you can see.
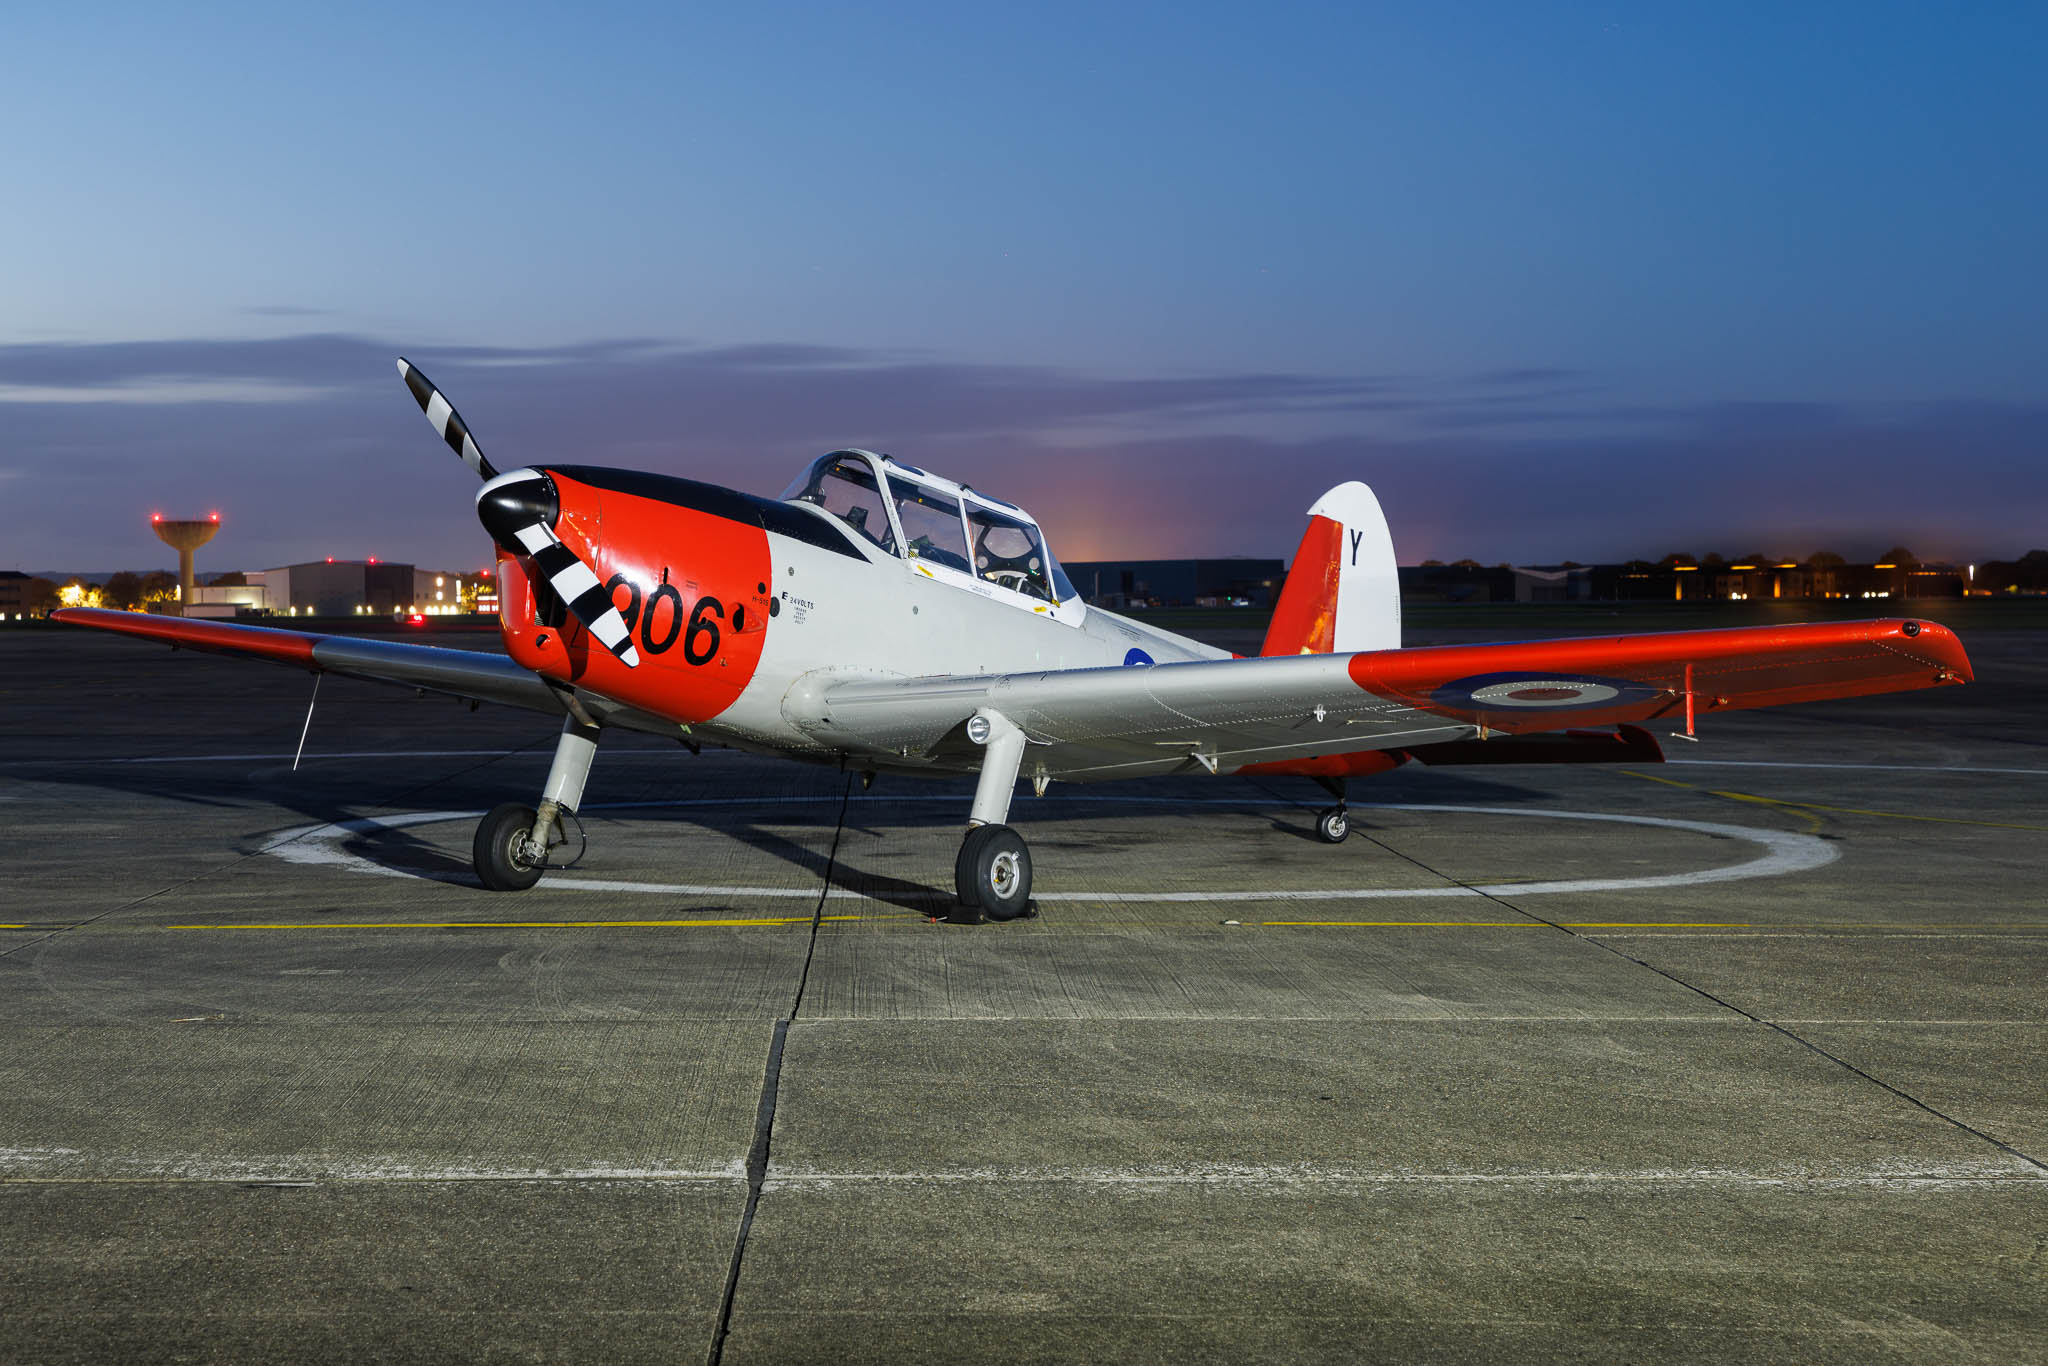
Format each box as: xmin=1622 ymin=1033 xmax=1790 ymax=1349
xmin=782 ymin=451 xmax=1079 ymax=606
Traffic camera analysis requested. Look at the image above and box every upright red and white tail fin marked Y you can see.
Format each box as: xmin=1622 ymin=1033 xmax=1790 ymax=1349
xmin=1260 ymin=479 xmax=1401 ymax=655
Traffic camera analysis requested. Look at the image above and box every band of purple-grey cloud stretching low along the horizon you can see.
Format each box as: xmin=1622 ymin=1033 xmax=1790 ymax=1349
xmin=0 ymin=334 xmax=2048 ymax=569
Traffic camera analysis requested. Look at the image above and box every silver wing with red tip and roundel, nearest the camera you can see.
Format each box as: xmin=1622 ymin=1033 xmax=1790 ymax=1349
xmin=803 ymin=621 xmax=1970 ymax=782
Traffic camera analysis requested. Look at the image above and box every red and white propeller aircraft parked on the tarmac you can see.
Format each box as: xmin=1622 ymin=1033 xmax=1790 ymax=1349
xmin=55 ymin=360 xmax=1970 ymax=920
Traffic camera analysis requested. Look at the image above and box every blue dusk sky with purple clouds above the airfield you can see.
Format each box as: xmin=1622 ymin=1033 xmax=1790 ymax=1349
xmin=0 ymin=0 xmax=2048 ymax=573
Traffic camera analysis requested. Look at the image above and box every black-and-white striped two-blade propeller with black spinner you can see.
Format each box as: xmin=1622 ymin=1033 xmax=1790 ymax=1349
xmin=397 ymin=356 xmax=639 ymax=670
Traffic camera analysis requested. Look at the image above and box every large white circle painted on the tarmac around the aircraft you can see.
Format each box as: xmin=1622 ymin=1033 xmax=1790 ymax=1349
xmin=262 ymin=795 xmax=1837 ymax=903
